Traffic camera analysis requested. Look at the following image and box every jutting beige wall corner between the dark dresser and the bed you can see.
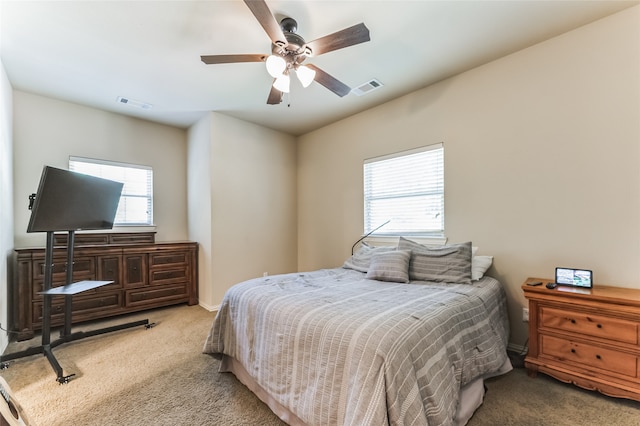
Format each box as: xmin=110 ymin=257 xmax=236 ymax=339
xmin=189 ymin=113 xmax=297 ymax=309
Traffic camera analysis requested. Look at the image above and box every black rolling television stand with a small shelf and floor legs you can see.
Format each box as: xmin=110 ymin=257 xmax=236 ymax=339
xmin=0 ymin=231 xmax=154 ymax=384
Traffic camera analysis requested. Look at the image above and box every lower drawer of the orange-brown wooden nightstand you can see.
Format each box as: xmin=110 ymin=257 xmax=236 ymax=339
xmin=540 ymin=335 xmax=638 ymax=377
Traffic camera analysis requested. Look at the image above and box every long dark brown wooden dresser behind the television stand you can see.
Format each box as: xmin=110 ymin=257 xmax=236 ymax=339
xmin=9 ymin=232 xmax=198 ymax=340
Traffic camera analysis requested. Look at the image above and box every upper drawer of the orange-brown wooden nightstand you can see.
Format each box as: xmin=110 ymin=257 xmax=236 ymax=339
xmin=540 ymin=307 xmax=638 ymax=345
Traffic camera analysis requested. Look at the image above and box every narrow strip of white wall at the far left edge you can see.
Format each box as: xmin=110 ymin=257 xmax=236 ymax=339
xmin=0 ymin=61 xmax=13 ymax=353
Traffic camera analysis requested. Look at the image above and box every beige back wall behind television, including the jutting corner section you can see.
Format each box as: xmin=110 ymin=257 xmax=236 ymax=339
xmin=8 ymin=91 xmax=297 ymax=316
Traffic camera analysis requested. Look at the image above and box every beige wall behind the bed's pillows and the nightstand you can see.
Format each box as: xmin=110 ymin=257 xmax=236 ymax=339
xmin=298 ymin=7 xmax=640 ymax=345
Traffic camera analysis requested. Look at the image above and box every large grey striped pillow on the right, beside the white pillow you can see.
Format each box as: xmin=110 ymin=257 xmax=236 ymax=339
xmin=398 ymin=237 xmax=471 ymax=284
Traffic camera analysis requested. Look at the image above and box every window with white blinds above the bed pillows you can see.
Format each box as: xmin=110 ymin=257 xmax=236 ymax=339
xmin=364 ymin=144 xmax=444 ymax=236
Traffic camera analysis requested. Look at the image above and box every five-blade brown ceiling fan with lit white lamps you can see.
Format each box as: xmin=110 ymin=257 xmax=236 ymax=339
xmin=200 ymin=0 xmax=371 ymax=105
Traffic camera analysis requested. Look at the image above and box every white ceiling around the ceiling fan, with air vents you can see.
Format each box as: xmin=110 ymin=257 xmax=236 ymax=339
xmin=0 ymin=0 xmax=639 ymax=135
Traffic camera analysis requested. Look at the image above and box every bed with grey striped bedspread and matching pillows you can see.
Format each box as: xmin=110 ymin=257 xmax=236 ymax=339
xmin=204 ymin=239 xmax=511 ymax=425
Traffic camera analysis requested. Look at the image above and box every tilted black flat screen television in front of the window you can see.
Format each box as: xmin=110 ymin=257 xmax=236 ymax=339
xmin=27 ymin=166 xmax=124 ymax=232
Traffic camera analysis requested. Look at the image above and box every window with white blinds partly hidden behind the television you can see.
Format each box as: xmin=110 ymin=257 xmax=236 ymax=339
xmin=69 ymin=157 xmax=153 ymax=226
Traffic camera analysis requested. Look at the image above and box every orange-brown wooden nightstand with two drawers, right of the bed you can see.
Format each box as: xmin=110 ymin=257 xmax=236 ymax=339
xmin=522 ymin=278 xmax=640 ymax=401
